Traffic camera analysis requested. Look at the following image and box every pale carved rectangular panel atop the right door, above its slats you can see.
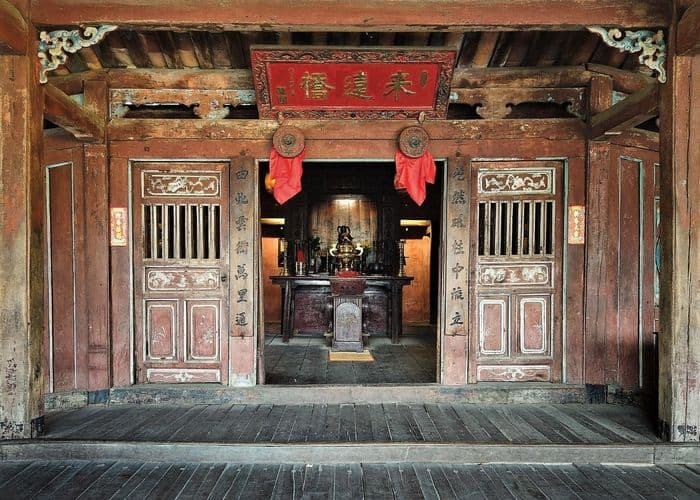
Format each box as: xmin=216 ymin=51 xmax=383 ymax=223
xmin=478 ymin=169 xmax=554 ymax=194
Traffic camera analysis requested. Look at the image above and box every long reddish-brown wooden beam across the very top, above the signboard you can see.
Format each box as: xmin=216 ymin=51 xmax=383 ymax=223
xmin=32 ymin=0 xmax=671 ymax=31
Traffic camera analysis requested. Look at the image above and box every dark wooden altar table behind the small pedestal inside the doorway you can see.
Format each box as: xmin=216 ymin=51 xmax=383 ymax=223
xmin=270 ymin=275 xmax=413 ymax=344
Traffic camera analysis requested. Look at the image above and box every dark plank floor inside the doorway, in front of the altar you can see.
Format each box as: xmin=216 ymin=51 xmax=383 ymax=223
xmin=265 ymin=326 xmax=437 ymax=385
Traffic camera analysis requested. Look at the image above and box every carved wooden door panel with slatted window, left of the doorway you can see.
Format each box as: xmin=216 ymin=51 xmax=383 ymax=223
xmin=132 ymin=162 xmax=229 ymax=383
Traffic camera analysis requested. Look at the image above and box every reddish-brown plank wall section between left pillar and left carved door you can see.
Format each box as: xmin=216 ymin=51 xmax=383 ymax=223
xmin=43 ymin=130 xmax=111 ymax=392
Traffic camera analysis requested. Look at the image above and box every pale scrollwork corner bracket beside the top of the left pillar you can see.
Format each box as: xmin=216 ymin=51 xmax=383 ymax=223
xmin=37 ymin=24 xmax=117 ymax=83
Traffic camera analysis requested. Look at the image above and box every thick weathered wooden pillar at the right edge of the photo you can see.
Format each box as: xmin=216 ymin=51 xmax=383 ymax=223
xmin=659 ymin=2 xmax=700 ymax=442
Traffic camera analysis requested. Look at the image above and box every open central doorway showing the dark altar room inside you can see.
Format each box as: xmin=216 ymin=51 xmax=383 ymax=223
xmin=258 ymin=161 xmax=445 ymax=385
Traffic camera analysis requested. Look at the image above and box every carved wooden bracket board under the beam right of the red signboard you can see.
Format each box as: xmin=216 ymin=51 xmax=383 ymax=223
xmin=450 ymin=87 xmax=585 ymax=119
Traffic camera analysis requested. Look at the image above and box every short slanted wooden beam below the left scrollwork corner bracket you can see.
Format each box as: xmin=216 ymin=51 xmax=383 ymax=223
xmin=44 ymin=84 xmax=105 ymax=142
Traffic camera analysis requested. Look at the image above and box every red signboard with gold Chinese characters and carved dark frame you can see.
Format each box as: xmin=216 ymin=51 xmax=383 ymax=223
xmin=251 ymin=47 xmax=455 ymax=119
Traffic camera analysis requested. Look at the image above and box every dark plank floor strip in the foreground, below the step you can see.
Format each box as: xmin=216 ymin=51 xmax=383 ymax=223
xmin=0 ymin=460 xmax=700 ymax=500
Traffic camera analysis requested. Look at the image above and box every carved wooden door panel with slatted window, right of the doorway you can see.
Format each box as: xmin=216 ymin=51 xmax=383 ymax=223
xmin=470 ymin=161 xmax=564 ymax=382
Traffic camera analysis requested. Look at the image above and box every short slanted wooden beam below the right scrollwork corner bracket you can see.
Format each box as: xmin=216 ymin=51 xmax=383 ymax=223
xmin=588 ymin=84 xmax=659 ymax=140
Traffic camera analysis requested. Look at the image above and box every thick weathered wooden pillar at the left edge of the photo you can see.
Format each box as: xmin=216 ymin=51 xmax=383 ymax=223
xmin=0 ymin=41 xmax=44 ymax=439
